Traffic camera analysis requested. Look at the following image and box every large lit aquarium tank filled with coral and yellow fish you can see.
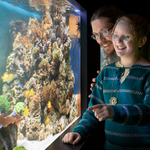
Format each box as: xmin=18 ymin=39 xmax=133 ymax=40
xmin=0 ymin=0 xmax=87 ymax=150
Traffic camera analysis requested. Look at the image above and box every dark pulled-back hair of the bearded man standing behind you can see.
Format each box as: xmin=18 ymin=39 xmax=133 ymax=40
xmin=91 ymin=5 xmax=125 ymax=24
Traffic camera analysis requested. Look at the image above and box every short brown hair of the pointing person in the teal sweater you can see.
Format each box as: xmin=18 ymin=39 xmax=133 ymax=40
xmin=112 ymin=14 xmax=150 ymax=40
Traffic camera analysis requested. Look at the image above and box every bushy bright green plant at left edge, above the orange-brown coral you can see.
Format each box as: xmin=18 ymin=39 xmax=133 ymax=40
xmin=0 ymin=95 xmax=10 ymax=113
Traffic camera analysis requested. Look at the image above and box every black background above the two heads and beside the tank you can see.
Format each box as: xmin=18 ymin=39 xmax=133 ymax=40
xmin=76 ymin=0 xmax=150 ymax=100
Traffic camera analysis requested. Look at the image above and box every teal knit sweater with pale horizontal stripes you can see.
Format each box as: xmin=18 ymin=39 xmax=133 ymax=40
xmin=72 ymin=63 xmax=150 ymax=150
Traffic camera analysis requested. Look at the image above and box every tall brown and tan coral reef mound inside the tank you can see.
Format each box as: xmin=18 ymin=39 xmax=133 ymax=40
xmin=0 ymin=0 xmax=79 ymax=144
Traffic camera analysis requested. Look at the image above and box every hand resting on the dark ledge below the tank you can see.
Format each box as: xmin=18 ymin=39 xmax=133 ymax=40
xmin=62 ymin=132 xmax=81 ymax=145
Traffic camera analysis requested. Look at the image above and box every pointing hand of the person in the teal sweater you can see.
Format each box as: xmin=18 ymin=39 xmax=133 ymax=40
xmin=88 ymin=104 xmax=113 ymax=121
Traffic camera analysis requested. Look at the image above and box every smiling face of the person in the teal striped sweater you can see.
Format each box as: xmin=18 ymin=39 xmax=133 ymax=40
xmin=112 ymin=20 xmax=139 ymax=57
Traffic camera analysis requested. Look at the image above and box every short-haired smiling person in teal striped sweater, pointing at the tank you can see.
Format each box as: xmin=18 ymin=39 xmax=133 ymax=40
xmin=63 ymin=15 xmax=150 ymax=150
